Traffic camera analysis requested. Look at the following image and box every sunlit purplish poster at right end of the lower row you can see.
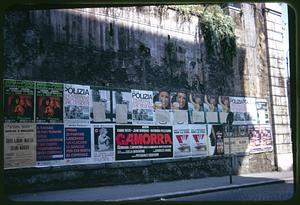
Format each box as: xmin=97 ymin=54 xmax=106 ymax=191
xmin=248 ymin=125 xmax=273 ymax=153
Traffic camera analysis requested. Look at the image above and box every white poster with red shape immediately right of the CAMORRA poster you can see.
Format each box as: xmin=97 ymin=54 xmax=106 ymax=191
xmin=173 ymin=125 xmax=191 ymax=157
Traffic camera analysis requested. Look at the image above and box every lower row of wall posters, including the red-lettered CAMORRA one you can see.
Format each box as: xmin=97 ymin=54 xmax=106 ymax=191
xmin=4 ymin=123 xmax=273 ymax=169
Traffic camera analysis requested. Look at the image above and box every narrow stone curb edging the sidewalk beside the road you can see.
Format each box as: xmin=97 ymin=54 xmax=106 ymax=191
xmin=105 ymin=178 xmax=293 ymax=202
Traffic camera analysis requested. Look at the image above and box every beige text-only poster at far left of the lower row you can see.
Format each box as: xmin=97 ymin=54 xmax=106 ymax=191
xmin=4 ymin=123 xmax=36 ymax=169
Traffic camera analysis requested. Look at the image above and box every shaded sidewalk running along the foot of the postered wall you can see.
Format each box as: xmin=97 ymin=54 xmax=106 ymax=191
xmin=8 ymin=171 xmax=293 ymax=201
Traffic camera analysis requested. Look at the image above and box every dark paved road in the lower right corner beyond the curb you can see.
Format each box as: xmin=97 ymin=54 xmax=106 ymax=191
xmin=166 ymin=181 xmax=294 ymax=201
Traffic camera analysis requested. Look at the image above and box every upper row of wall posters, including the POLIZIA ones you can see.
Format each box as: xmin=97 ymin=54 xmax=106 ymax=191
xmin=4 ymin=80 xmax=269 ymax=125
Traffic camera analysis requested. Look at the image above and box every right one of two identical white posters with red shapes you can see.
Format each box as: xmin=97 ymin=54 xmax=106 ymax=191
xmin=190 ymin=125 xmax=208 ymax=156
